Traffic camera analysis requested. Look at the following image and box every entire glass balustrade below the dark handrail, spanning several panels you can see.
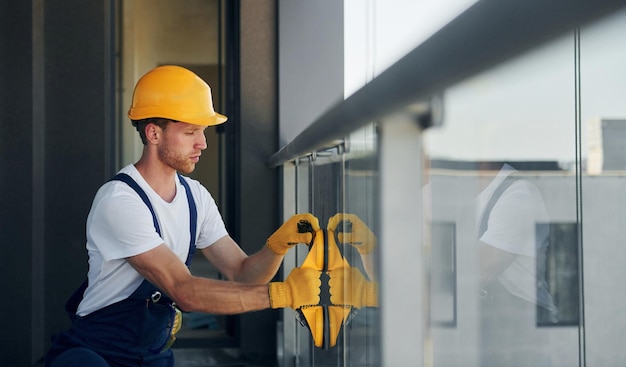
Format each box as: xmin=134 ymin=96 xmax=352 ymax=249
xmin=276 ymin=2 xmax=626 ymax=367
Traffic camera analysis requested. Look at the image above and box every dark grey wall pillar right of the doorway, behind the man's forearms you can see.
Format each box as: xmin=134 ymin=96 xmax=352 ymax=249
xmin=233 ymin=0 xmax=279 ymax=360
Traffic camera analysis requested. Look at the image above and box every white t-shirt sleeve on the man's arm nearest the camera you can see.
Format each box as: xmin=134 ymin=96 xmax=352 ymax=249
xmin=87 ymin=190 xmax=163 ymax=261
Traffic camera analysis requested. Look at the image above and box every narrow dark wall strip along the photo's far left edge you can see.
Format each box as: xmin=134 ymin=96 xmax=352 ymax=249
xmin=0 ymin=0 xmax=33 ymax=366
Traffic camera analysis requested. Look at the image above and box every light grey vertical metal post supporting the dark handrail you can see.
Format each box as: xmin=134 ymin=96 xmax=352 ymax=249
xmin=378 ymin=116 xmax=427 ymax=366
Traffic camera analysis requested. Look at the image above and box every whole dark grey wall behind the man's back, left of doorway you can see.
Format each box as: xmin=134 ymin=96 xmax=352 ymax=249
xmin=0 ymin=0 xmax=113 ymax=366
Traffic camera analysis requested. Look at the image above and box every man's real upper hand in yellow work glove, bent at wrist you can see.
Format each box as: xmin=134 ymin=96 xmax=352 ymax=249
xmin=266 ymin=213 xmax=320 ymax=255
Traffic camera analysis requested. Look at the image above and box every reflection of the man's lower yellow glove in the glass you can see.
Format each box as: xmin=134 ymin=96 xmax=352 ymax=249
xmin=328 ymin=267 xmax=378 ymax=308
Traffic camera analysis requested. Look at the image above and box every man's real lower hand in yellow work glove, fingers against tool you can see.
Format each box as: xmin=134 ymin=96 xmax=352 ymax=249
xmin=269 ymin=268 xmax=322 ymax=310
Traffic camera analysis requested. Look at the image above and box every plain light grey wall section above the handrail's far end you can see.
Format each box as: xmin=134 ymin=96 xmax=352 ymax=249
xmin=278 ymin=0 xmax=344 ymax=147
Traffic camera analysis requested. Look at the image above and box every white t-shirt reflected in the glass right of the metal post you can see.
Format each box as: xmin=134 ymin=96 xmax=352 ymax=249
xmin=477 ymin=165 xmax=554 ymax=310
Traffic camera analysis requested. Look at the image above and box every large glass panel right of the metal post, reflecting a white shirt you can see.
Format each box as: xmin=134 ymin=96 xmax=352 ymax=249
xmin=424 ymin=28 xmax=581 ymax=367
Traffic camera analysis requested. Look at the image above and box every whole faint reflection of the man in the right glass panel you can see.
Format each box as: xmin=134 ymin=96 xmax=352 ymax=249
xmin=476 ymin=163 xmax=556 ymax=367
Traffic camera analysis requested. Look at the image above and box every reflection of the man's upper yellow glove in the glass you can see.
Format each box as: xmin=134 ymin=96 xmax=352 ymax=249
xmin=326 ymin=213 xmax=376 ymax=254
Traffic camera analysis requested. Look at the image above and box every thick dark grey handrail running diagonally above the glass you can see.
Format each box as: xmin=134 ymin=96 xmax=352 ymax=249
xmin=268 ymin=0 xmax=626 ymax=167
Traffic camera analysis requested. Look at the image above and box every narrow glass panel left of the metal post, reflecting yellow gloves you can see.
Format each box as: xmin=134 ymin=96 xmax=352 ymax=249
xmin=286 ymin=125 xmax=380 ymax=366
